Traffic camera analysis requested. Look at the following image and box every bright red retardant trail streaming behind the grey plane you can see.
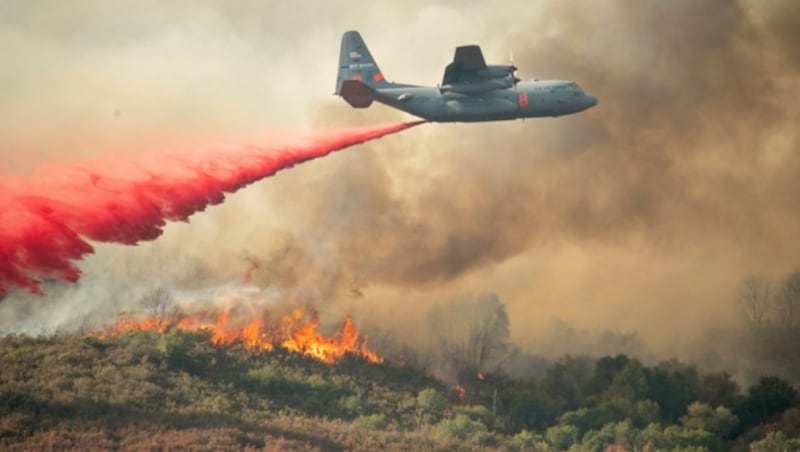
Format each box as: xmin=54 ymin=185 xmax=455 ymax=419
xmin=0 ymin=121 xmax=422 ymax=295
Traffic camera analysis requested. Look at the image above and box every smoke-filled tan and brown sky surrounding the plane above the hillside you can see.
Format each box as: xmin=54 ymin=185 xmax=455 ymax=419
xmin=0 ymin=0 xmax=800 ymax=376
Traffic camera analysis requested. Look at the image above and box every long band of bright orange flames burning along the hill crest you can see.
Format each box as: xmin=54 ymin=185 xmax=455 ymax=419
xmin=100 ymin=306 xmax=383 ymax=364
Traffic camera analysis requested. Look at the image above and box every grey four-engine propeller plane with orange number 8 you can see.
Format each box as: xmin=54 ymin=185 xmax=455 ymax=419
xmin=335 ymin=30 xmax=597 ymax=122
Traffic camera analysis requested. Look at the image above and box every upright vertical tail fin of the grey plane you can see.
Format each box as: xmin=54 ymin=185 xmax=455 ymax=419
xmin=336 ymin=30 xmax=391 ymax=94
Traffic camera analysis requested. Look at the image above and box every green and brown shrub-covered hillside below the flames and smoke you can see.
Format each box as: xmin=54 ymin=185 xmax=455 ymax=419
xmin=0 ymin=330 xmax=800 ymax=451
